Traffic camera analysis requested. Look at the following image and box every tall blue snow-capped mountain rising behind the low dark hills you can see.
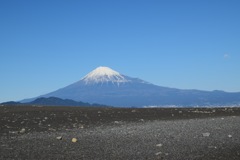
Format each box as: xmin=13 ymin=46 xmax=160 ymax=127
xmin=23 ymin=67 xmax=240 ymax=107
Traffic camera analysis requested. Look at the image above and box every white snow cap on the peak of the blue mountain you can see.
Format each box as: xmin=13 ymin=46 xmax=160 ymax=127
xmin=82 ymin=66 xmax=128 ymax=84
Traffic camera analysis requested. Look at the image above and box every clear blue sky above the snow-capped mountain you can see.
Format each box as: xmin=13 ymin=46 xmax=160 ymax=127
xmin=0 ymin=0 xmax=240 ymax=102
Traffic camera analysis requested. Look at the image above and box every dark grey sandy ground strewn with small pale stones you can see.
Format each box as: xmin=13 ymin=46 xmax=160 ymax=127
xmin=0 ymin=107 xmax=240 ymax=160
